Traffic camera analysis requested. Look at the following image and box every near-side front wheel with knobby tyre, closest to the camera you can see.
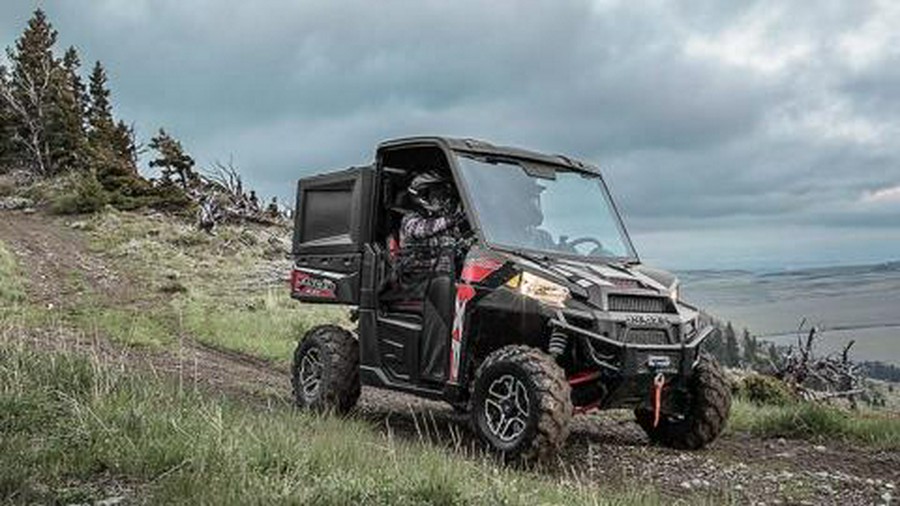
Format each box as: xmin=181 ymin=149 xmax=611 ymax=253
xmin=469 ymin=346 xmax=572 ymax=460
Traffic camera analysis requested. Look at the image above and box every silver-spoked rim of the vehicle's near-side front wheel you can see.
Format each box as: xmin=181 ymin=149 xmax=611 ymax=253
xmin=484 ymin=374 xmax=531 ymax=443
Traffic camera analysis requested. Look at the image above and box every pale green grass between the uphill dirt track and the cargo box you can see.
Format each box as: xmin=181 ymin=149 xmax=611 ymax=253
xmin=74 ymin=210 xmax=349 ymax=365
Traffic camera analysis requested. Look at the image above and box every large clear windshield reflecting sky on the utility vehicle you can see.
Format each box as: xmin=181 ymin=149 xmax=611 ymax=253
xmin=457 ymin=154 xmax=636 ymax=259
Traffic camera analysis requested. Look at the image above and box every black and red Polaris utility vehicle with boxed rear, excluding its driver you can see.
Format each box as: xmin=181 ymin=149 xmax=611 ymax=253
xmin=291 ymin=137 xmax=731 ymax=459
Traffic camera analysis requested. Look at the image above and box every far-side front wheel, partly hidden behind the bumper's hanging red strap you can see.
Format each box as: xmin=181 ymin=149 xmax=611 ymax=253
xmin=635 ymin=355 xmax=731 ymax=450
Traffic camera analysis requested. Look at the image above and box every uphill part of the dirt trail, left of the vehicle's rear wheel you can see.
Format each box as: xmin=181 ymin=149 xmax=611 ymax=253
xmin=0 ymin=212 xmax=288 ymax=400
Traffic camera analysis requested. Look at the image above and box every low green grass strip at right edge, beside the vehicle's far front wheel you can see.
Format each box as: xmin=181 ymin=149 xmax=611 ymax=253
xmin=728 ymin=399 xmax=900 ymax=450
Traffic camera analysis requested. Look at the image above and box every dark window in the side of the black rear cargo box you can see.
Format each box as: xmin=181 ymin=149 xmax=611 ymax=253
xmin=300 ymin=186 xmax=353 ymax=244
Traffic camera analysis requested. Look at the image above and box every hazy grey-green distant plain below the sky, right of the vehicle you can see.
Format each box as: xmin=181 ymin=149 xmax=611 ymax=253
xmin=678 ymin=262 xmax=900 ymax=365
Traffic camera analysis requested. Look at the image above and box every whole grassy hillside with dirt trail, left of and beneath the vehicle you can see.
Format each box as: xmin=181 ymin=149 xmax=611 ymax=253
xmin=0 ymin=207 xmax=900 ymax=504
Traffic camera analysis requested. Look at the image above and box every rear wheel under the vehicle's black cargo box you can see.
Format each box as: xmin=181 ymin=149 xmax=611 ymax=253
xmin=291 ymin=325 xmax=360 ymax=413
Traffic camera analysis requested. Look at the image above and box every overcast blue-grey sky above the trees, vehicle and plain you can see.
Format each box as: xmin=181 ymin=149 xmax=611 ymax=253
xmin=0 ymin=0 xmax=900 ymax=268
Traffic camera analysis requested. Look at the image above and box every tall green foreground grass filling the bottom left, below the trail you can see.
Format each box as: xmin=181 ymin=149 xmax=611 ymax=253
xmin=0 ymin=336 xmax=659 ymax=505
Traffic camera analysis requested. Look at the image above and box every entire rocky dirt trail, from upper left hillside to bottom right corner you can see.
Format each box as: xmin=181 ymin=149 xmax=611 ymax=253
xmin=0 ymin=212 xmax=900 ymax=504
